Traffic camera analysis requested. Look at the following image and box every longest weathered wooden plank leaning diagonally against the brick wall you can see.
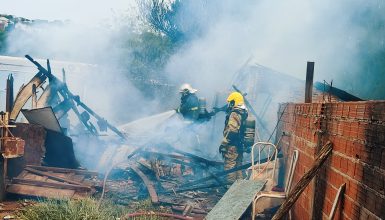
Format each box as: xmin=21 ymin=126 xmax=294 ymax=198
xmin=272 ymin=141 xmax=333 ymax=220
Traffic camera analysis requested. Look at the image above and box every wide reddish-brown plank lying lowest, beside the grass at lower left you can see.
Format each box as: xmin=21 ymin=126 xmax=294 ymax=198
xmin=7 ymin=184 xmax=75 ymax=199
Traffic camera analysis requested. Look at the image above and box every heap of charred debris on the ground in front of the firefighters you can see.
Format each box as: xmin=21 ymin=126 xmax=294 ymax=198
xmin=101 ymin=146 xmax=227 ymax=217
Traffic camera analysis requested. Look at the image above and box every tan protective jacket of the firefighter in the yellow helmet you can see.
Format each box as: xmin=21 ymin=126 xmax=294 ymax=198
xmin=221 ymin=105 xmax=248 ymax=150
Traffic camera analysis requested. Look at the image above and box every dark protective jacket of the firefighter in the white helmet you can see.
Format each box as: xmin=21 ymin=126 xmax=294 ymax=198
xmin=178 ymin=93 xmax=199 ymax=120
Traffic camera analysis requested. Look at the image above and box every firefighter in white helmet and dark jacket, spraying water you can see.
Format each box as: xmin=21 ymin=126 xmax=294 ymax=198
xmin=176 ymin=83 xmax=199 ymax=120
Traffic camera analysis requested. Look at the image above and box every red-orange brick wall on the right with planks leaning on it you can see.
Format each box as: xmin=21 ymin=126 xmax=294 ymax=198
xmin=277 ymin=101 xmax=385 ymax=219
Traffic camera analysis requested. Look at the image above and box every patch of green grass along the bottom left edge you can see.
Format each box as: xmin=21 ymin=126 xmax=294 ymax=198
xmin=16 ymin=198 xmax=170 ymax=220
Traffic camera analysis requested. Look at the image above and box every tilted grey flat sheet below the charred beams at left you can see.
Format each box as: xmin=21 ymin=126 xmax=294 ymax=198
xmin=21 ymin=107 xmax=62 ymax=133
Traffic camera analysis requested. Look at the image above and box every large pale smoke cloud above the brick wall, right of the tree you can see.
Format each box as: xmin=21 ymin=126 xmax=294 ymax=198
xmin=167 ymin=0 xmax=385 ymax=99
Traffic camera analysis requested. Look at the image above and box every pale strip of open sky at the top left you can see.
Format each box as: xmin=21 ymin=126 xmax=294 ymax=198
xmin=0 ymin=0 xmax=135 ymax=23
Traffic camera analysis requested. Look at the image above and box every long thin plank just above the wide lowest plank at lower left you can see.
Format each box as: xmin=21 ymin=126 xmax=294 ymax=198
xmin=12 ymin=178 xmax=91 ymax=191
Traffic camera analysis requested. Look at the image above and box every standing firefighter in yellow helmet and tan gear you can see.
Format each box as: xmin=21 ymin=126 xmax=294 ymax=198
xmin=219 ymin=92 xmax=248 ymax=183
